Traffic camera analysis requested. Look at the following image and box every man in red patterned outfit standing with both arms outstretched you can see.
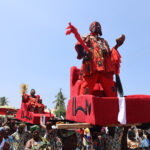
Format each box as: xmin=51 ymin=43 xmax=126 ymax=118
xmin=66 ymin=22 xmax=125 ymax=97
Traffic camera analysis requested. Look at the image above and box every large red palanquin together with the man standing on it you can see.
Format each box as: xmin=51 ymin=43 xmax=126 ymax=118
xmin=66 ymin=22 xmax=150 ymax=126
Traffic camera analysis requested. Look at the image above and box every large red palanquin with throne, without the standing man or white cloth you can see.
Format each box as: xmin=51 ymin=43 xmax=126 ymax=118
xmin=66 ymin=66 xmax=150 ymax=125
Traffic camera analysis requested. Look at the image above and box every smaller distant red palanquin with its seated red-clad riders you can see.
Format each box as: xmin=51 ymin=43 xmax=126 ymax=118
xmin=16 ymin=84 xmax=54 ymax=124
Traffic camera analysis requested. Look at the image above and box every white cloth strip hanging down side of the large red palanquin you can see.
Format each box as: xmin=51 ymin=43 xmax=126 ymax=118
xmin=118 ymin=97 xmax=126 ymax=124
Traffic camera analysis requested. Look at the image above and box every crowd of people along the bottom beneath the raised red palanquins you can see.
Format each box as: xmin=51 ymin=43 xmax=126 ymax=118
xmin=0 ymin=116 xmax=150 ymax=150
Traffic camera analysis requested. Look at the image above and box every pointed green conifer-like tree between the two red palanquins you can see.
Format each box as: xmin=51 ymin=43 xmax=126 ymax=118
xmin=53 ymin=89 xmax=66 ymax=118
